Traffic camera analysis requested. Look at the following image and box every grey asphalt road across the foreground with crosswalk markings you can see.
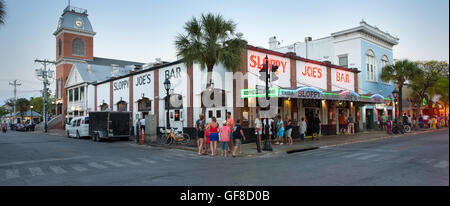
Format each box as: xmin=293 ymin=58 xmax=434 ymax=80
xmin=0 ymin=130 xmax=449 ymax=186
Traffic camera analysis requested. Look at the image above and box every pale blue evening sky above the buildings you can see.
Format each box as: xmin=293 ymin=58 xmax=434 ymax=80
xmin=0 ymin=0 xmax=449 ymax=105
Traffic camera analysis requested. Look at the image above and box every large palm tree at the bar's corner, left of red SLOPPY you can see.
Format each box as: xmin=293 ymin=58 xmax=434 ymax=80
xmin=175 ymin=13 xmax=247 ymax=113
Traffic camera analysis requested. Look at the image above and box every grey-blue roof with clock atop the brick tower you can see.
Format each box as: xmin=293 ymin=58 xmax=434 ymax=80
xmin=53 ymin=6 xmax=95 ymax=35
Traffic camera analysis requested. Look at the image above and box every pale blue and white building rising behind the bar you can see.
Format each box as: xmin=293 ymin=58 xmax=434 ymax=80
xmin=269 ymin=21 xmax=399 ymax=129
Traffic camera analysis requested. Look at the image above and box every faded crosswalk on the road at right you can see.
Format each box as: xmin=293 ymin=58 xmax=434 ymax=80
xmin=293 ymin=149 xmax=449 ymax=169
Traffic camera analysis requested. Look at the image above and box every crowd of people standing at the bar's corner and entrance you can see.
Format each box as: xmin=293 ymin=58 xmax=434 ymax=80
xmin=195 ymin=112 xmax=320 ymax=157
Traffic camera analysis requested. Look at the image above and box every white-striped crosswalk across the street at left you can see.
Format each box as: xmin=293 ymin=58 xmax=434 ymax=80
xmin=0 ymin=153 xmax=206 ymax=182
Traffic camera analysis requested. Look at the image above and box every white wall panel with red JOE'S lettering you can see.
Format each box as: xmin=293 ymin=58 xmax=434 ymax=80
xmin=296 ymin=61 xmax=327 ymax=90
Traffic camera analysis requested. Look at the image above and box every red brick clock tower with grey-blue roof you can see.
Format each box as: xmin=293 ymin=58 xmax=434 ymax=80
xmin=53 ymin=6 xmax=95 ymax=125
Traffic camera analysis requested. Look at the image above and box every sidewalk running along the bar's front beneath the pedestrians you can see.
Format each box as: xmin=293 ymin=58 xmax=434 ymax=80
xmin=145 ymin=127 xmax=448 ymax=157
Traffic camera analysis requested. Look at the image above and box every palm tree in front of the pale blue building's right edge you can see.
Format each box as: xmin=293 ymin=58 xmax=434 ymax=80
xmin=381 ymin=59 xmax=422 ymax=120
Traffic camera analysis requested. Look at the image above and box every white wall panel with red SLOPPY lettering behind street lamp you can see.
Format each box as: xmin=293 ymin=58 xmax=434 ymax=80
xmin=247 ymin=50 xmax=291 ymax=88
